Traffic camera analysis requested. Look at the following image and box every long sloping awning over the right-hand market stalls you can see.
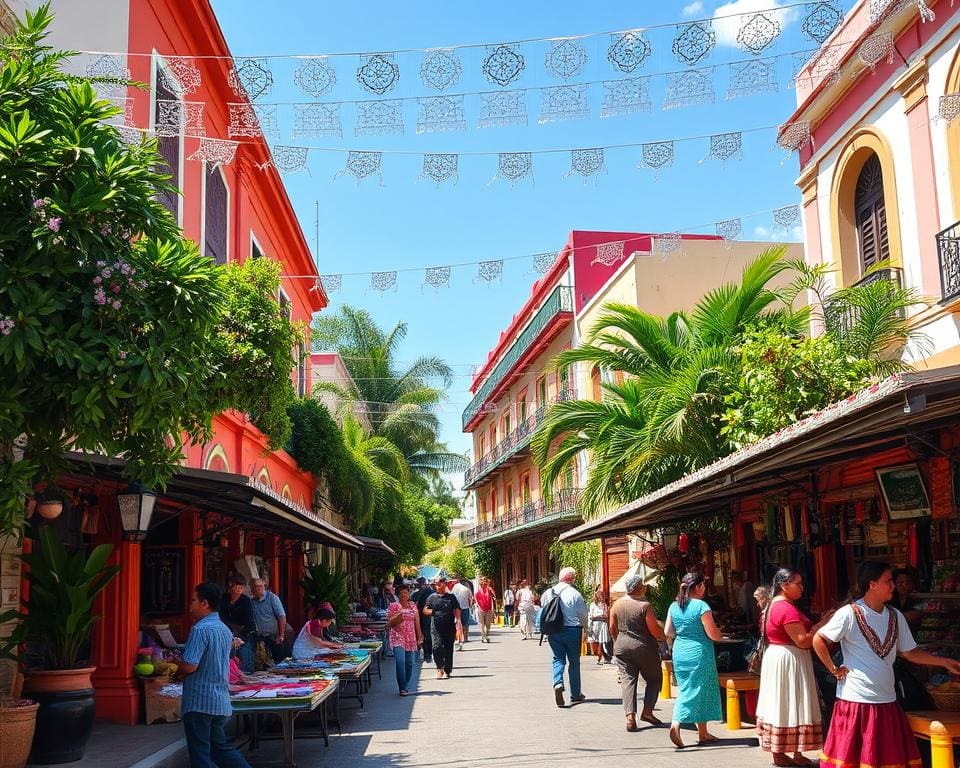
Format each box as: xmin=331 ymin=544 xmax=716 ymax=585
xmin=560 ymin=366 xmax=960 ymax=541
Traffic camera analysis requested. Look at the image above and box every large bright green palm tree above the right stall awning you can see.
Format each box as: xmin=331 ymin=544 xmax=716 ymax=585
xmin=532 ymin=247 xmax=917 ymax=516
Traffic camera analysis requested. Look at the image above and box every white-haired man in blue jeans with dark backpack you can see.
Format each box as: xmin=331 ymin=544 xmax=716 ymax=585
xmin=540 ymin=568 xmax=587 ymax=707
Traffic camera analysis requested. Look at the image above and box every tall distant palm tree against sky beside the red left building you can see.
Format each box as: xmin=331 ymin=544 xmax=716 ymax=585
xmin=313 ymin=306 xmax=467 ymax=474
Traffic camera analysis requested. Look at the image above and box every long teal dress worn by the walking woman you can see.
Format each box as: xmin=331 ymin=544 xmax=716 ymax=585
xmin=670 ymin=599 xmax=722 ymax=723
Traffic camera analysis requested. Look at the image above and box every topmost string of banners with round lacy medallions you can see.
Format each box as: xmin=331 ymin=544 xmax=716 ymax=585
xmin=88 ymin=0 xmax=933 ymax=108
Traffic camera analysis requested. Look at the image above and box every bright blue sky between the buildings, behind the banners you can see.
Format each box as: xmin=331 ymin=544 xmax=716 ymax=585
xmin=213 ymin=0 xmax=850 ymax=462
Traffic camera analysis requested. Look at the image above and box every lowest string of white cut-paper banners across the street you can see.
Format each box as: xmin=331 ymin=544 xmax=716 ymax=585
xmin=306 ymin=205 xmax=800 ymax=295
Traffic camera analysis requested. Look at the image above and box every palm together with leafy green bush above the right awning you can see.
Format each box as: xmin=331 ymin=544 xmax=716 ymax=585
xmin=532 ymin=247 xmax=918 ymax=516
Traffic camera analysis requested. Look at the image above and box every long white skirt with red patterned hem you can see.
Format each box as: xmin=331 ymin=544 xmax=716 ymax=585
xmin=757 ymin=644 xmax=823 ymax=754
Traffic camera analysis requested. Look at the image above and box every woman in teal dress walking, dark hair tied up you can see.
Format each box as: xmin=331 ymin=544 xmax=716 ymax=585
xmin=666 ymin=573 xmax=723 ymax=749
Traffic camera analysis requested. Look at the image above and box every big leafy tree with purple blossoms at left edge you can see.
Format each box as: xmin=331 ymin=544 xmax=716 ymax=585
xmin=0 ymin=6 xmax=295 ymax=533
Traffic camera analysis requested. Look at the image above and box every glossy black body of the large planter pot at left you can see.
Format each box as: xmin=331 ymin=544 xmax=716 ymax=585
xmin=25 ymin=669 xmax=97 ymax=765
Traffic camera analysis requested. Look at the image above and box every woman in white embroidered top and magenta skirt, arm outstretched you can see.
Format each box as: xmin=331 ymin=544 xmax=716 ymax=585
xmin=813 ymin=561 xmax=960 ymax=768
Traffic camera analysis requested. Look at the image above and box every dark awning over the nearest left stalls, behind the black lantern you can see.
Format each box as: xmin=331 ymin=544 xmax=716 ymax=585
xmin=66 ymin=452 xmax=362 ymax=550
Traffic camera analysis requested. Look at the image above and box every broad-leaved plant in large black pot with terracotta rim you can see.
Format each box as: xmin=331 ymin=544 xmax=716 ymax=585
xmin=14 ymin=526 xmax=120 ymax=763
